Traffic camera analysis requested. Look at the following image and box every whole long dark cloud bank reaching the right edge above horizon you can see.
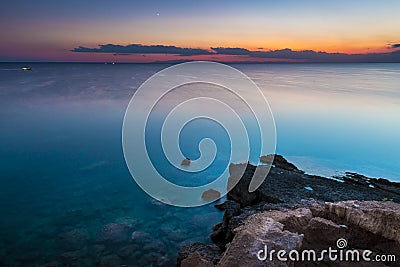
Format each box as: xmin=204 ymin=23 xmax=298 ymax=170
xmin=71 ymin=44 xmax=400 ymax=63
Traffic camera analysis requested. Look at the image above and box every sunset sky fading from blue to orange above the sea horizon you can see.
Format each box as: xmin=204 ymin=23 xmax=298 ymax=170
xmin=0 ymin=0 xmax=400 ymax=62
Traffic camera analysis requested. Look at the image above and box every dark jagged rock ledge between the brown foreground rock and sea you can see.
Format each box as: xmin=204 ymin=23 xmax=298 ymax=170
xmin=227 ymin=155 xmax=400 ymax=207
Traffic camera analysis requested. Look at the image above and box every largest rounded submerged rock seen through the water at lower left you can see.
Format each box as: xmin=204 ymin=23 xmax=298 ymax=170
xmin=97 ymin=223 xmax=132 ymax=243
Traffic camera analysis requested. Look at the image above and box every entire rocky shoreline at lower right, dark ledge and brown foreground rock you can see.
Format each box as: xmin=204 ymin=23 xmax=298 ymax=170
xmin=177 ymin=155 xmax=400 ymax=267
